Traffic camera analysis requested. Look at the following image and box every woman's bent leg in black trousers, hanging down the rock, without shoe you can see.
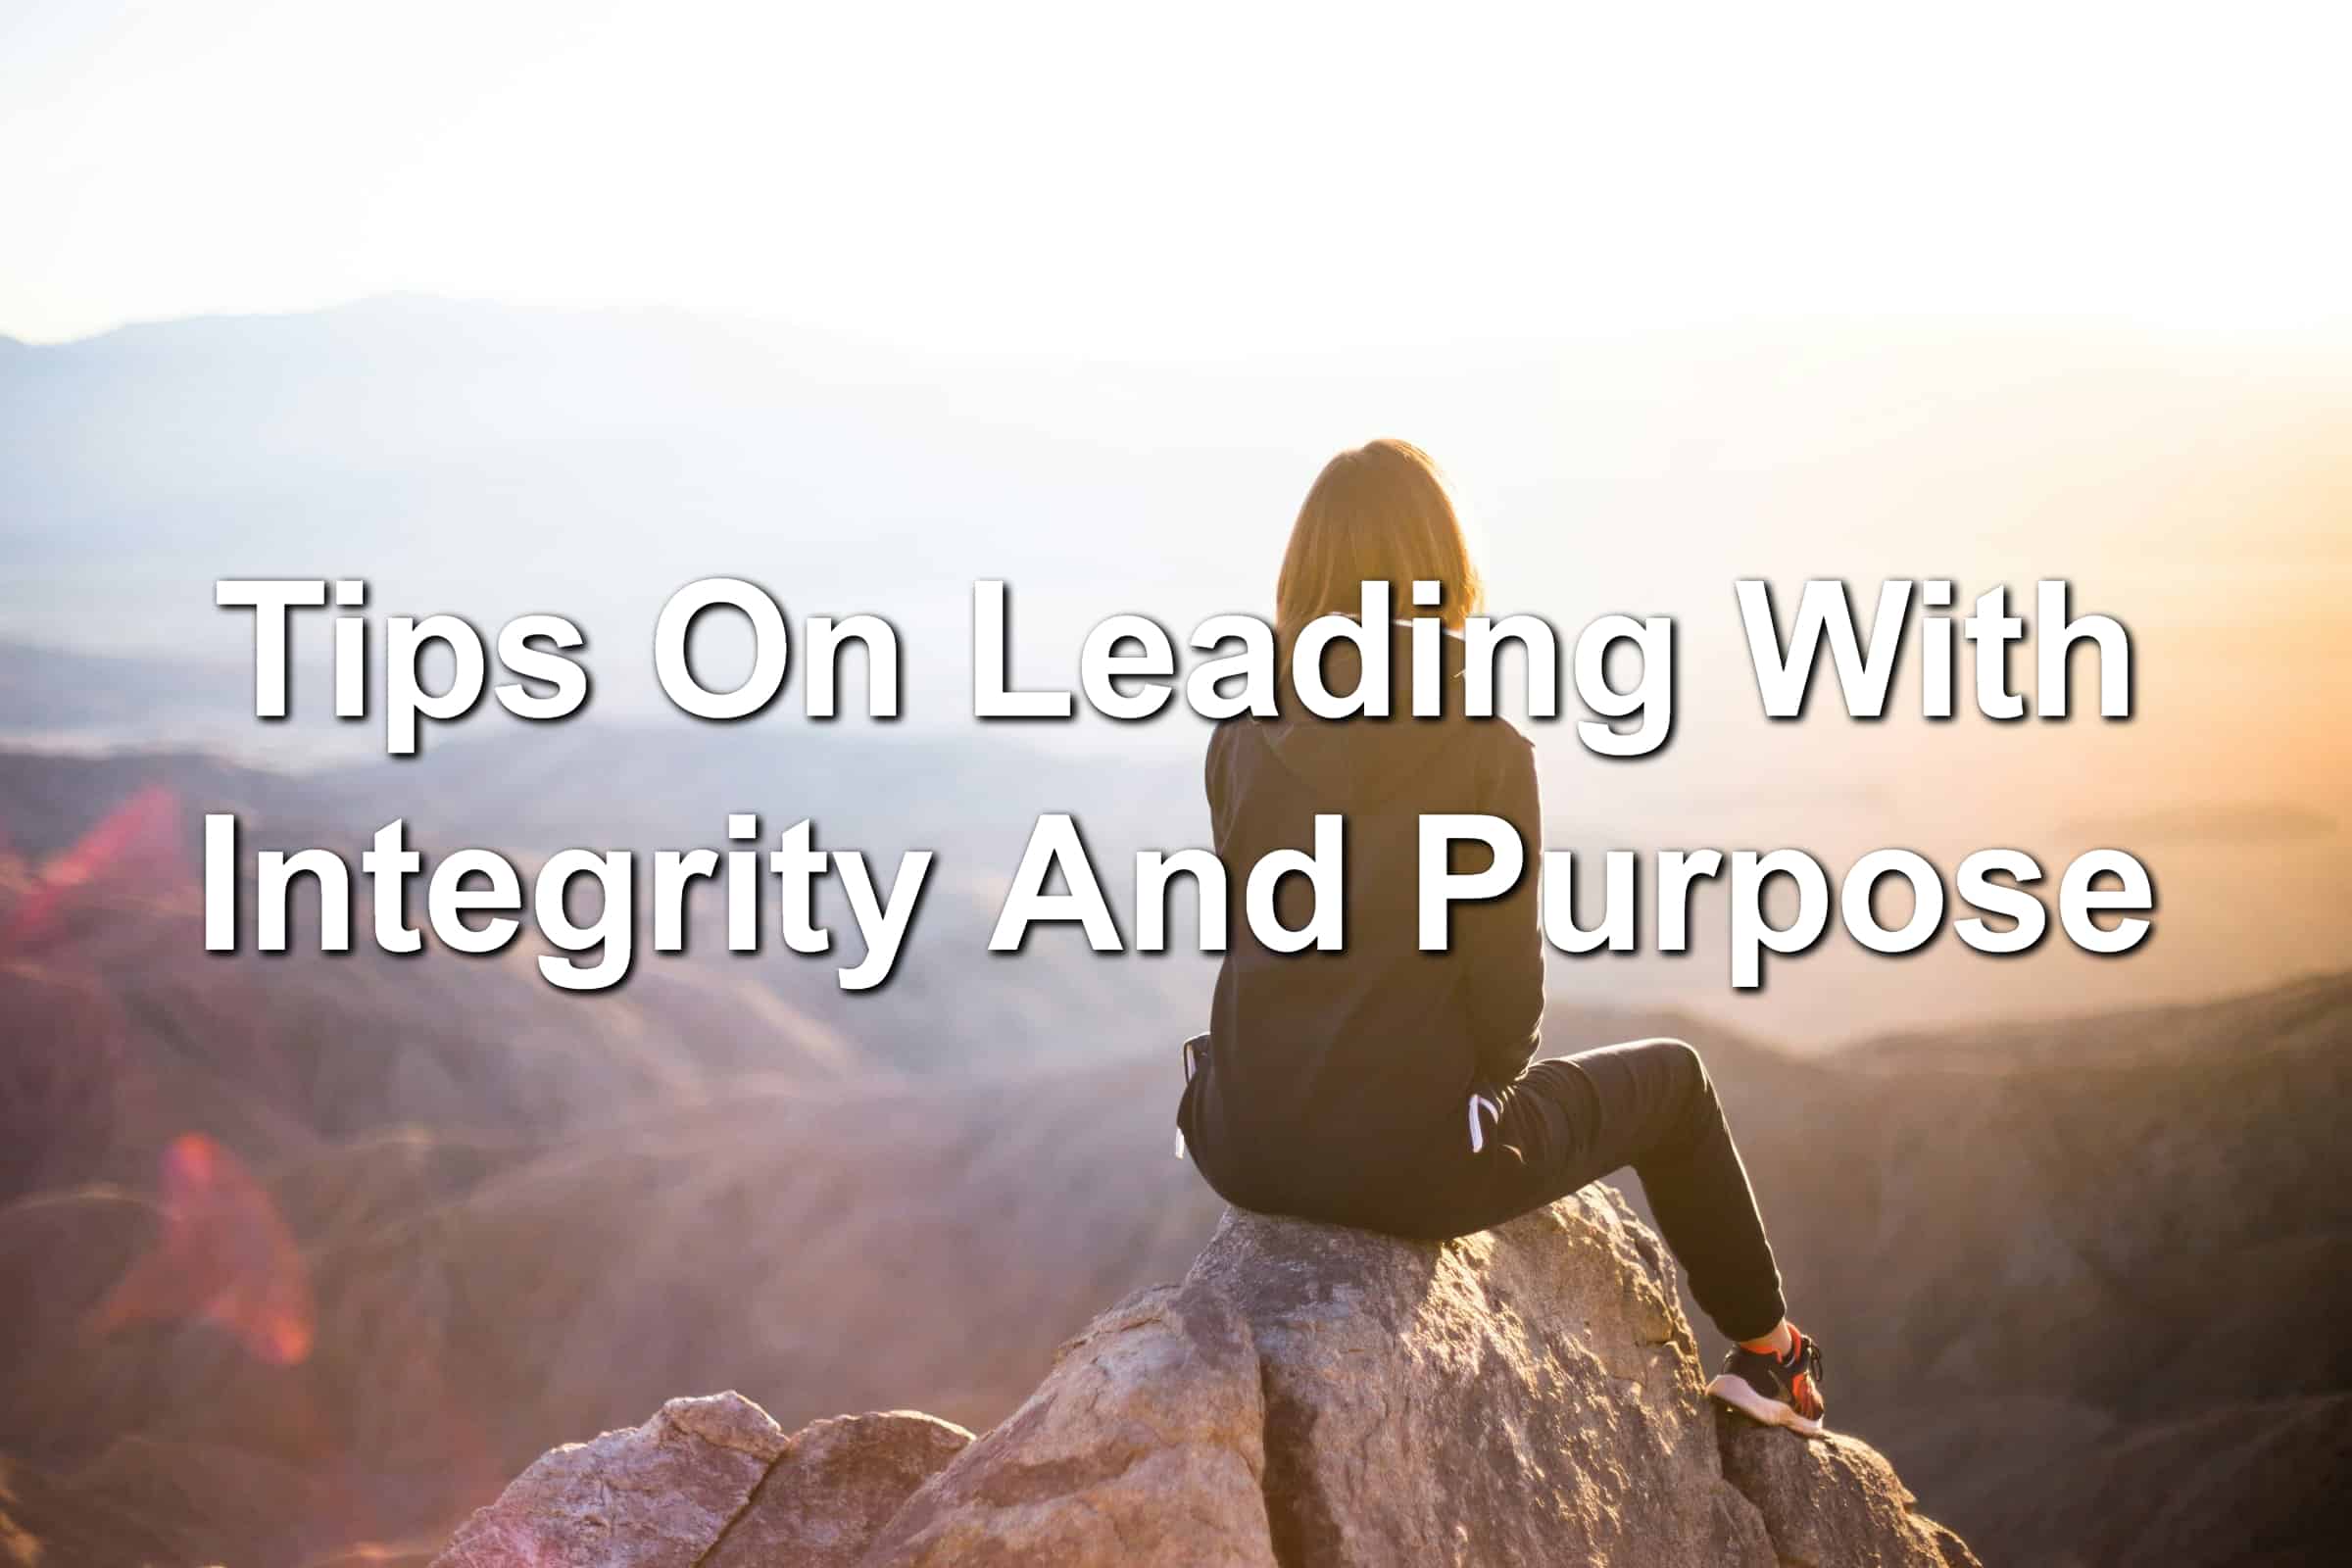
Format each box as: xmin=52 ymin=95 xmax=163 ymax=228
xmin=1489 ymin=1039 xmax=1786 ymax=1340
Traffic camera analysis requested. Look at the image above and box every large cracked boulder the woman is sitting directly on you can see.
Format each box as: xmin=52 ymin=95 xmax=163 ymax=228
xmin=868 ymin=1190 xmax=1794 ymax=1568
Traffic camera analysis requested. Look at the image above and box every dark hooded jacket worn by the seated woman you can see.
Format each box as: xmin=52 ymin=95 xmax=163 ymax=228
xmin=1178 ymin=627 xmax=1543 ymax=1232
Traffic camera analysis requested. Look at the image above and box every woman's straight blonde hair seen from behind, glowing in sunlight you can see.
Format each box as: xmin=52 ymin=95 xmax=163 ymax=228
xmin=1275 ymin=440 xmax=1487 ymax=649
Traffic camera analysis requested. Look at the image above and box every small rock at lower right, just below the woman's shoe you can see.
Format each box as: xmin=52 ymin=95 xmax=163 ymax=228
xmin=1717 ymin=1410 xmax=1983 ymax=1568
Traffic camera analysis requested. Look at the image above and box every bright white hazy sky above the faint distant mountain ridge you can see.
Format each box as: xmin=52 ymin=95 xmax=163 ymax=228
xmin=14 ymin=0 xmax=2352 ymax=353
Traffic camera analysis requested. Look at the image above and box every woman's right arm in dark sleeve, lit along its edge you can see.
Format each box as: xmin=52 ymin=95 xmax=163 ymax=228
xmin=1453 ymin=719 xmax=1543 ymax=1086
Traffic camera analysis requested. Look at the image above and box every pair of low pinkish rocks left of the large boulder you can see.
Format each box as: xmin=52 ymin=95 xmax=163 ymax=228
xmin=433 ymin=1394 xmax=971 ymax=1568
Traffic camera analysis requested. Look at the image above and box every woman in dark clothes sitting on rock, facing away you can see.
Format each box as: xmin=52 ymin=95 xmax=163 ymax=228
xmin=1176 ymin=442 xmax=1823 ymax=1434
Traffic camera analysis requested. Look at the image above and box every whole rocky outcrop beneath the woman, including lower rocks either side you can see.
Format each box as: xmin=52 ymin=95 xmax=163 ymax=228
xmin=442 ymin=1187 xmax=1976 ymax=1568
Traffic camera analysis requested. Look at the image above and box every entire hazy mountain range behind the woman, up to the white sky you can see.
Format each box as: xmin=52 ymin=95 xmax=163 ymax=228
xmin=0 ymin=299 xmax=2352 ymax=1568
